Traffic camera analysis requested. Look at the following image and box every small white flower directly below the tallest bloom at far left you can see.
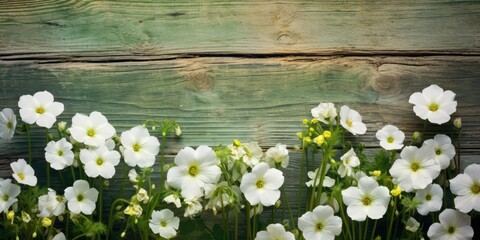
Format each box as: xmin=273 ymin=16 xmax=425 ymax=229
xmin=45 ymin=138 xmax=74 ymax=170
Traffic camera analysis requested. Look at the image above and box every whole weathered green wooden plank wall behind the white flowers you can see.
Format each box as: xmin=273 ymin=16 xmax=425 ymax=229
xmin=0 ymin=0 xmax=480 ymax=238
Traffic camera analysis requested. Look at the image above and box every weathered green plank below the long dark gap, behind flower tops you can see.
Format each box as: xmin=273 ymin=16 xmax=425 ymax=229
xmin=0 ymin=56 xmax=480 ymax=158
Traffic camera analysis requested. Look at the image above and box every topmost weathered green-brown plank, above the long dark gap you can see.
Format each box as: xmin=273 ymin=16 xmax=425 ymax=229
xmin=0 ymin=0 xmax=480 ymax=55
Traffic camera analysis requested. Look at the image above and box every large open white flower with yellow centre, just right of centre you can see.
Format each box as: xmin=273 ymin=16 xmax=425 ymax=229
xmin=240 ymin=162 xmax=284 ymax=207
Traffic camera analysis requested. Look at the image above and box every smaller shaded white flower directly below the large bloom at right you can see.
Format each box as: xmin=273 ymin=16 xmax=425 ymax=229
xmin=415 ymin=184 xmax=443 ymax=216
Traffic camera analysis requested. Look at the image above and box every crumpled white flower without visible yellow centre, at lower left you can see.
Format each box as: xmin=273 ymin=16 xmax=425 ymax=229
xmin=37 ymin=188 xmax=66 ymax=218
